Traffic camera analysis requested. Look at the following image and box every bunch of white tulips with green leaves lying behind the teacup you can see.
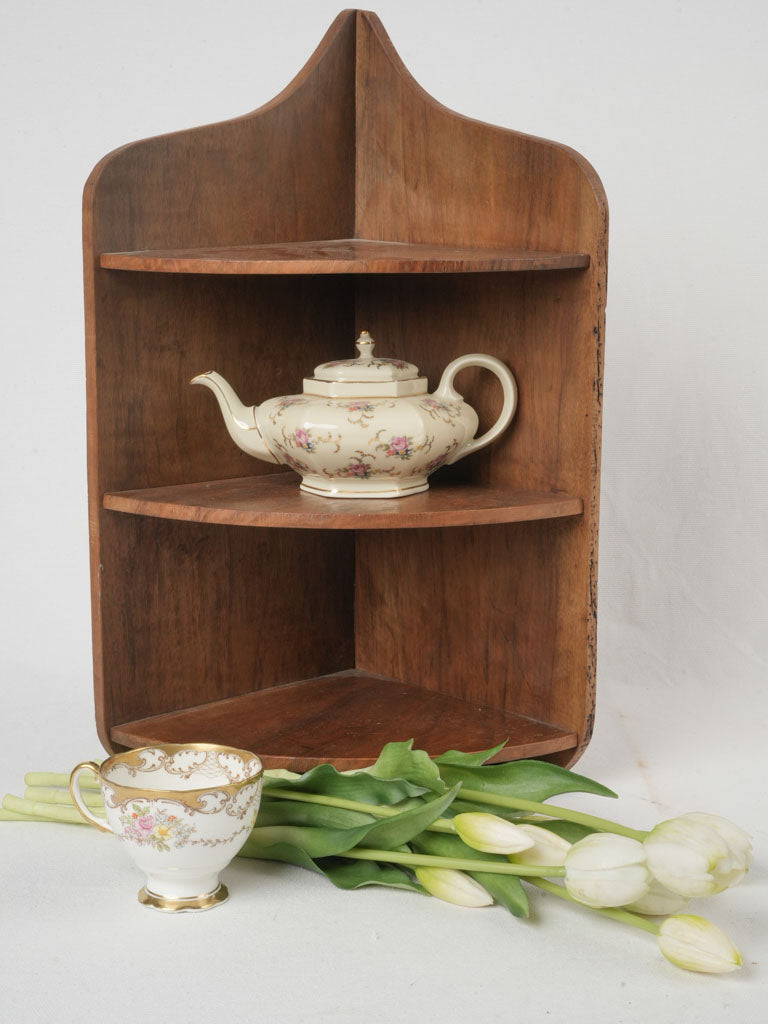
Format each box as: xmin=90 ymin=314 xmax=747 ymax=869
xmin=0 ymin=742 xmax=752 ymax=973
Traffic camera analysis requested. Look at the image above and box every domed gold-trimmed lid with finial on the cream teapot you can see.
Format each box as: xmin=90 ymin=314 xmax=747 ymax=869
xmin=304 ymin=331 xmax=427 ymax=396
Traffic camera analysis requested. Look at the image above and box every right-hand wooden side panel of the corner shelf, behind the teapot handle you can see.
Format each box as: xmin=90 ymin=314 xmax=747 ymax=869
xmin=355 ymin=12 xmax=607 ymax=763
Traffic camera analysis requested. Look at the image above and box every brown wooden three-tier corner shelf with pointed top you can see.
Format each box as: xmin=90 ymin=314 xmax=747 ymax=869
xmin=84 ymin=10 xmax=607 ymax=770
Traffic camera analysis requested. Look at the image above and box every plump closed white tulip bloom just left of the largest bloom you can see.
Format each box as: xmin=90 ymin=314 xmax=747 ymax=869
xmin=565 ymin=833 xmax=650 ymax=908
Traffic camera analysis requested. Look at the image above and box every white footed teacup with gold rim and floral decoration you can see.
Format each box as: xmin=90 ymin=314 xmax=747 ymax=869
xmin=70 ymin=743 xmax=263 ymax=911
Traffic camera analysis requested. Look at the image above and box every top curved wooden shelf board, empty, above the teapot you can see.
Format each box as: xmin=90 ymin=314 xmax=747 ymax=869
xmin=100 ymin=239 xmax=590 ymax=274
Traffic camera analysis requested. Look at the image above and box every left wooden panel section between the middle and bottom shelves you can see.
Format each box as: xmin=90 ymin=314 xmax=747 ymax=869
xmin=97 ymin=520 xmax=354 ymax=740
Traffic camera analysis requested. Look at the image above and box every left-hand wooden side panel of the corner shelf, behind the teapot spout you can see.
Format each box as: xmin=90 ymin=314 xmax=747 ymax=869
xmin=83 ymin=12 xmax=355 ymax=750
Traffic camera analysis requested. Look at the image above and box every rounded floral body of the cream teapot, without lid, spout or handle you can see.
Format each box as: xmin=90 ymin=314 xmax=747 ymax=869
xmin=256 ymin=392 xmax=477 ymax=498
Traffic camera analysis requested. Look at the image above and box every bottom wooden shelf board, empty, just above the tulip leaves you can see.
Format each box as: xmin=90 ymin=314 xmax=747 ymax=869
xmin=111 ymin=669 xmax=578 ymax=771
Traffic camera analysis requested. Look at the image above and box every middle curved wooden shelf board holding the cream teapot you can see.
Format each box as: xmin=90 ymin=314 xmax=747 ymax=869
xmin=103 ymin=473 xmax=584 ymax=529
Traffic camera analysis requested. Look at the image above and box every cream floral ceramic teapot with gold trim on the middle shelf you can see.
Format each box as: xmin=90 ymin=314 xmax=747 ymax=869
xmin=191 ymin=331 xmax=517 ymax=498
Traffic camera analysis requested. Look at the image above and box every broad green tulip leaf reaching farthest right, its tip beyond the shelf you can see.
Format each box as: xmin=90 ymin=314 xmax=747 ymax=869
xmin=439 ymin=761 xmax=615 ymax=802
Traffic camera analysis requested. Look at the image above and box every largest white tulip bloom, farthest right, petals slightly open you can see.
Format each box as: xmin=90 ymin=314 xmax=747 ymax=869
xmin=644 ymin=813 xmax=752 ymax=897
